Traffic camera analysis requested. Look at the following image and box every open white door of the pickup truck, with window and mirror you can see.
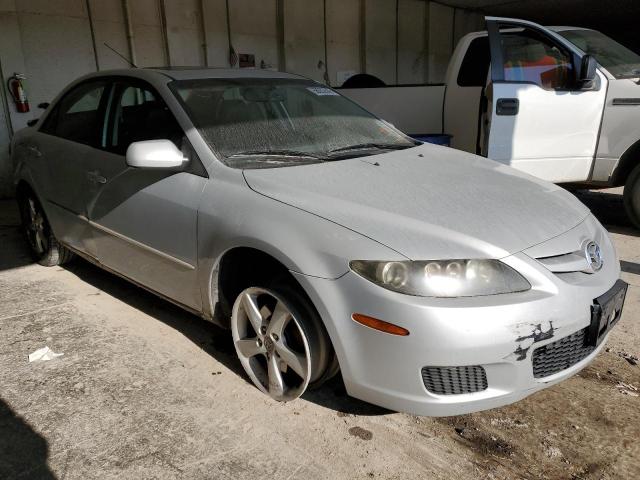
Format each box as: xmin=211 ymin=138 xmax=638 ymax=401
xmin=487 ymin=17 xmax=607 ymax=183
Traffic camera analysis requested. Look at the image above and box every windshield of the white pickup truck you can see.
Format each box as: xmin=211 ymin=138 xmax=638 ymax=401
xmin=558 ymin=30 xmax=640 ymax=78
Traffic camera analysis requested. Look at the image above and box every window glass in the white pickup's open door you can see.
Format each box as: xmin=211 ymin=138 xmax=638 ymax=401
xmin=500 ymin=29 xmax=573 ymax=89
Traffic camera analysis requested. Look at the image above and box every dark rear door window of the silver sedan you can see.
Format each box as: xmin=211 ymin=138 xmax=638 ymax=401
xmin=42 ymin=81 xmax=107 ymax=145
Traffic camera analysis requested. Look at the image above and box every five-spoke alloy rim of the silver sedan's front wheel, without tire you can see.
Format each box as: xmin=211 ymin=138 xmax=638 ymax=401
xmin=231 ymin=287 xmax=311 ymax=402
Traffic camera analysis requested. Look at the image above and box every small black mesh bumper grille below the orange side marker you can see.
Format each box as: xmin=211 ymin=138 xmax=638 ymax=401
xmin=422 ymin=365 xmax=487 ymax=395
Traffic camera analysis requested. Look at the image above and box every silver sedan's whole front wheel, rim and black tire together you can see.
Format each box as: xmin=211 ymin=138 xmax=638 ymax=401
xmin=231 ymin=284 xmax=335 ymax=402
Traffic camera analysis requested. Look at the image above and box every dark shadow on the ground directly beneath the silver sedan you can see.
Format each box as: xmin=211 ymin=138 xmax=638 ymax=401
xmin=64 ymin=258 xmax=390 ymax=415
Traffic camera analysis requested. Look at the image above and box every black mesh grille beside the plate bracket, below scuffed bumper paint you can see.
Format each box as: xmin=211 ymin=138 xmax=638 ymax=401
xmin=533 ymin=328 xmax=595 ymax=378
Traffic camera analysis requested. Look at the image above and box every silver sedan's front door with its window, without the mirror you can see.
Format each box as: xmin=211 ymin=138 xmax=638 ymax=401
xmin=87 ymin=79 xmax=207 ymax=310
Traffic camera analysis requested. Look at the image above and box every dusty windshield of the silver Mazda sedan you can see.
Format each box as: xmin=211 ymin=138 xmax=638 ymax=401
xmin=171 ymin=78 xmax=416 ymax=168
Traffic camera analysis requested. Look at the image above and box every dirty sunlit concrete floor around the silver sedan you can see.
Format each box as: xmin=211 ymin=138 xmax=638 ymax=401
xmin=0 ymin=191 xmax=640 ymax=479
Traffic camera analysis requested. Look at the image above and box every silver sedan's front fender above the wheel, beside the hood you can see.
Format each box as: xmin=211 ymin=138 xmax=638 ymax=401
xmin=198 ymin=170 xmax=406 ymax=316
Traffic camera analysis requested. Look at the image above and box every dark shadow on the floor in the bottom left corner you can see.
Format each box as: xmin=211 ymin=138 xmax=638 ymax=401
xmin=0 ymin=398 xmax=56 ymax=480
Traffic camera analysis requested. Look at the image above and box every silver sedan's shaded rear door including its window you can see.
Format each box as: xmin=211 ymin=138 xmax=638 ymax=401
xmin=27 ymin=79 xmax=110 ymax=256
